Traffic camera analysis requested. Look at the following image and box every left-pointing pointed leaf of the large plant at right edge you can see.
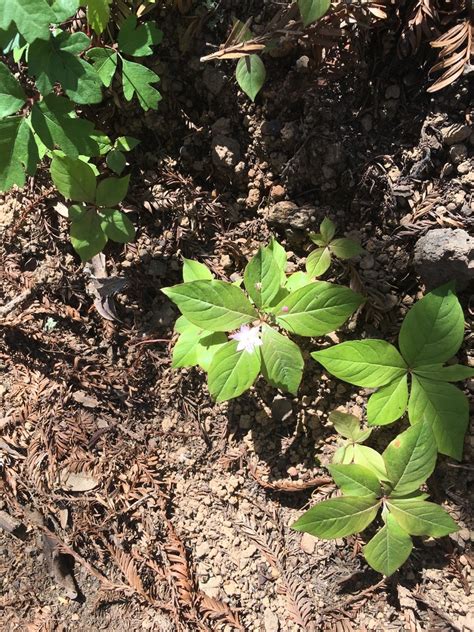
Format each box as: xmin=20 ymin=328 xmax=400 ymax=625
xmin=311 ymin=340 xmax=407 ymax=388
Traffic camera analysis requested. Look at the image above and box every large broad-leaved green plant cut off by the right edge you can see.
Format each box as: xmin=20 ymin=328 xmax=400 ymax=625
xmin=312 ymin=284 xmax=474 ymax=459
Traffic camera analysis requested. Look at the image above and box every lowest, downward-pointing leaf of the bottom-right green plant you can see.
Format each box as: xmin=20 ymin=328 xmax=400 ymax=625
xmin=363 ymin=514 xmax=413 ymax=577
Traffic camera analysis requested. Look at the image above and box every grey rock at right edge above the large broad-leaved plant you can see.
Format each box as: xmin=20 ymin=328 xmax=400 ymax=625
xmin=413 ymin=228 xmax=474 ymax=289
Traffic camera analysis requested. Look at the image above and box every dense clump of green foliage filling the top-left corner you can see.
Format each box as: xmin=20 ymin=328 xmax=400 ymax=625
xmin=0 ymin=0 xmax=162 ymax=258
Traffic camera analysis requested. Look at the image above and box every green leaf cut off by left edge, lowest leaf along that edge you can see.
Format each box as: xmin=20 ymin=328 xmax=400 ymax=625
xmin=0 ymin=116 xmax=39 ymax=191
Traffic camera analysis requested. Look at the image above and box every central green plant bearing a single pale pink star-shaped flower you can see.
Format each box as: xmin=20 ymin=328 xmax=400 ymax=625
xmin=162 ymin=239 xmax=364 ymax=402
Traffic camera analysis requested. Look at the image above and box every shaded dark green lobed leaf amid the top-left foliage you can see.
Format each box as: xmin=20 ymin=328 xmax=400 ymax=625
xmin=28 ymin=32 xmax=102 ymax=104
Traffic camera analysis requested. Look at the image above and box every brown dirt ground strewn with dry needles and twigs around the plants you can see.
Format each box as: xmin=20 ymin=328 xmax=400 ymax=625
xmin=0 ymin=3 xmax=474 ymax=632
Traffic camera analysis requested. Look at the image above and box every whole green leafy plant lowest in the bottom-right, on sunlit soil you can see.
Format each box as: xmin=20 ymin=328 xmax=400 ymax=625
xmin=292 ymin=419 xmax=459 ymax=576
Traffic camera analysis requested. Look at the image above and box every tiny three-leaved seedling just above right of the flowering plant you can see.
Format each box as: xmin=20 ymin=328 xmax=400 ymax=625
xmin=306 ymin=217 xmax=365 ymax=277
